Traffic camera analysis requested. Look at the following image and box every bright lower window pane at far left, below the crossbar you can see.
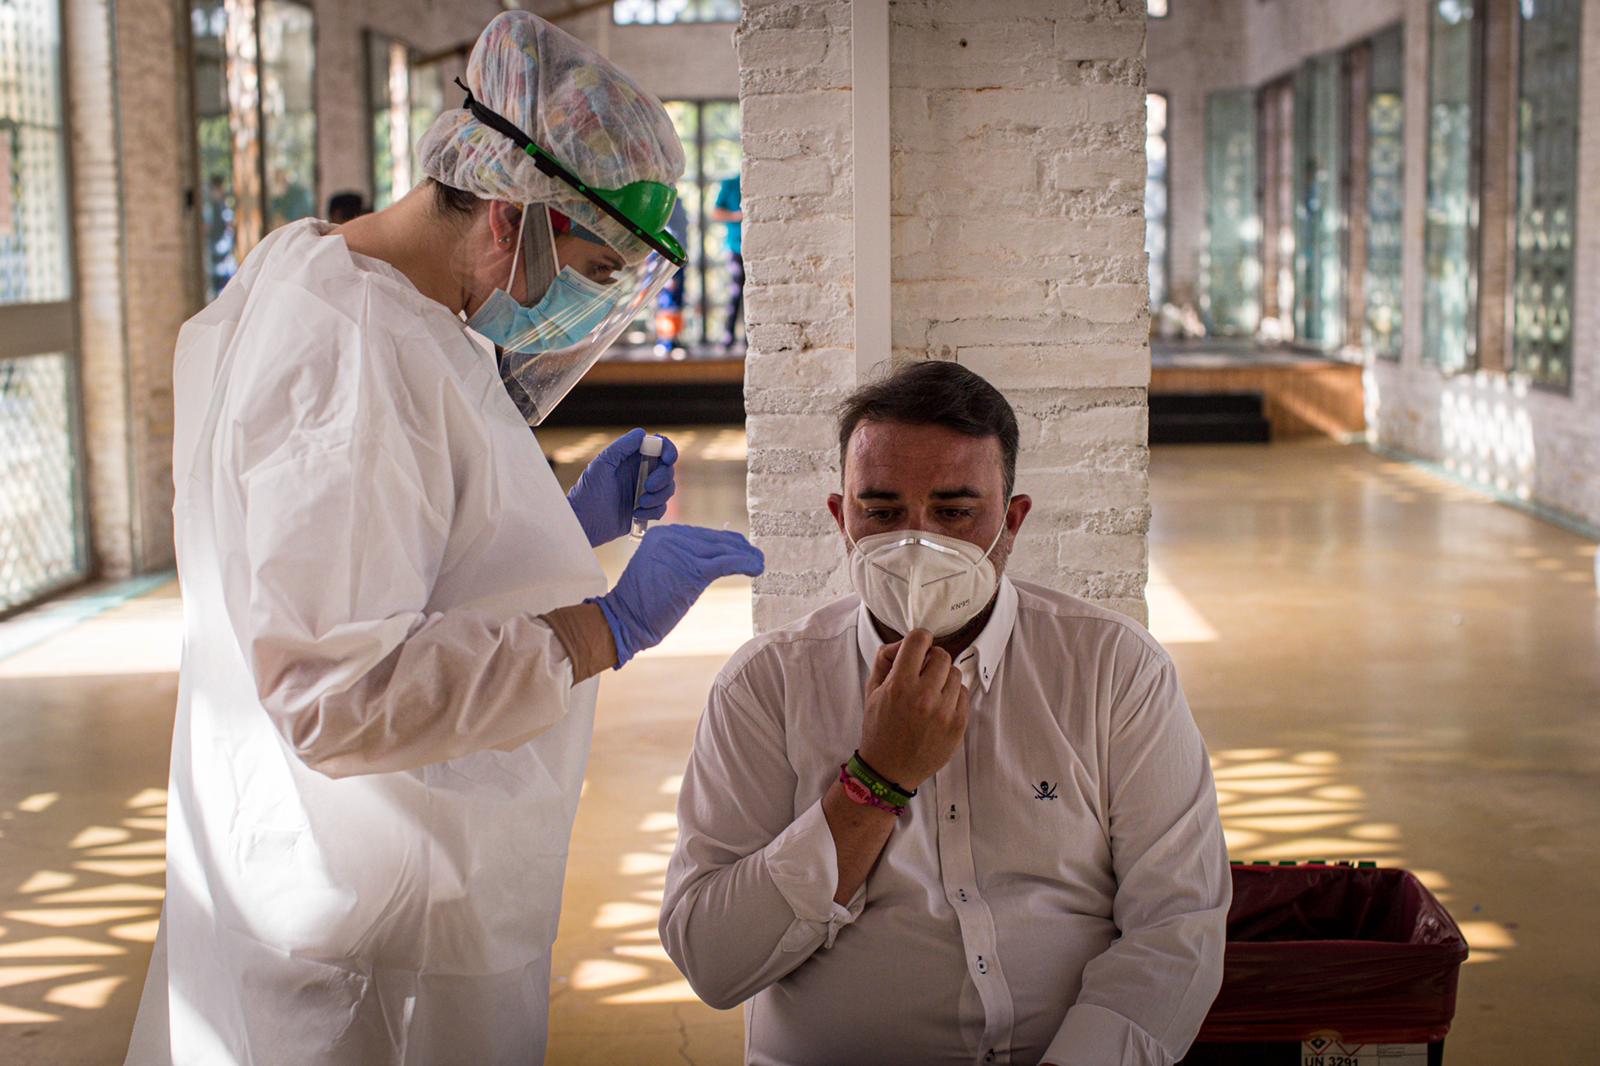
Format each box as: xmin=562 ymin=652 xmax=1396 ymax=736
xmin=0 ymin=354 xmax=83 ymax=611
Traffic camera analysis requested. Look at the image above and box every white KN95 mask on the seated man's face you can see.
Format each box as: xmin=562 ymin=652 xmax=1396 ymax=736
xmin=845 ymin=522 xmax=1005 ymax=637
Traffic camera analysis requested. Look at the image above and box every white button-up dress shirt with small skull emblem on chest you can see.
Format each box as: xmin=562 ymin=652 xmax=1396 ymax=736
xmin=661 ymin=579 xmax=1230 ymax=1066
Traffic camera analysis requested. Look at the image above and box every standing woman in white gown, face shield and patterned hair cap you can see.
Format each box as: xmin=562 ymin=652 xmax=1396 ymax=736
xmin=128 ymin=11 xmax=762 ymax=1066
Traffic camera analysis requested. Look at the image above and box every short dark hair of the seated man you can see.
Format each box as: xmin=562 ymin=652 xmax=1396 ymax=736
xmin=838 ymin=360 xmax=1018 ymax=496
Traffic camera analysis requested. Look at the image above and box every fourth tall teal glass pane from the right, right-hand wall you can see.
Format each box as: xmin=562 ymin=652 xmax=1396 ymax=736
xmin=1294 ymin=56 xmax=1344 ymax=349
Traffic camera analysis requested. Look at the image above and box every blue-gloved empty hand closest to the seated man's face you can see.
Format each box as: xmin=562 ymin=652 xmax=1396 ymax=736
xmin=587 ymin=525 xmax=765 ymax=667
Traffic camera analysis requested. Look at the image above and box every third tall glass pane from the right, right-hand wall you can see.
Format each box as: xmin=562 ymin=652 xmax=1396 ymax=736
xmin=1366 ymin=26 xmax=1405 ymax=359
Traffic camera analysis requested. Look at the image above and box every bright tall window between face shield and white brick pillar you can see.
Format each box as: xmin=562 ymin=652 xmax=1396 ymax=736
xmin=666 ymin=99 xmax=741 ymax=344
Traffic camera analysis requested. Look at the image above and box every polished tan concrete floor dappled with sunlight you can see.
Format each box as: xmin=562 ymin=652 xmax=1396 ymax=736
xmin=0 ymin=429 xmax=1600 ymax=1066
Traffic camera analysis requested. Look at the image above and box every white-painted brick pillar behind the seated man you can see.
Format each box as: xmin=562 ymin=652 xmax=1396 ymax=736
xmin=736 ymin=0 xmax=1149 ymax=629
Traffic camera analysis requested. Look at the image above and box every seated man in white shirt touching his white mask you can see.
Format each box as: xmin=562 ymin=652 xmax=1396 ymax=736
xmin=661 ymin=362 xmax=1230 ymax=1066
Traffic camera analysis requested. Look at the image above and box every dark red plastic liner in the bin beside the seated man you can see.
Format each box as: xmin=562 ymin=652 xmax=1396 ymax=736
xmin=1197 ymin=866 xmax=1467 ymax=1044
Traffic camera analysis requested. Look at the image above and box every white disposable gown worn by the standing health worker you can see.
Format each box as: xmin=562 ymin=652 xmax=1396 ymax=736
xmin=128 ymin=221 xmax=605 ymax=1066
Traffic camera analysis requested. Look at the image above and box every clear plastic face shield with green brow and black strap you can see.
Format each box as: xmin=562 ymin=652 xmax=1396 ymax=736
xmin=458 ymin=80 xmax=685 ymax=426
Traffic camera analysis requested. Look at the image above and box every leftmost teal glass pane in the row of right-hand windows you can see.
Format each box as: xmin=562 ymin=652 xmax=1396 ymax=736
xmin=1200 ymin=90 xmax=1261 ymax=336
